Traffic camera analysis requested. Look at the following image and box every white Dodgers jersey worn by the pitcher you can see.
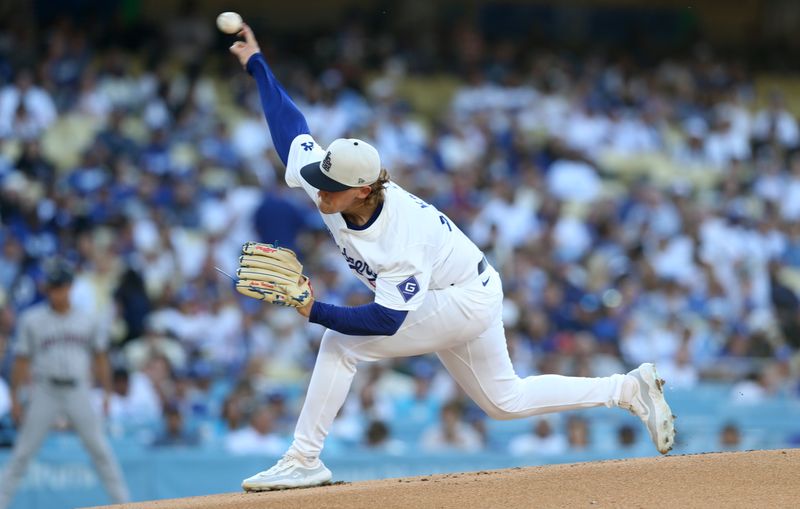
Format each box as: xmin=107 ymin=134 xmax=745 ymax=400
xmin=286 ymin=134 xmax=483 ymax=311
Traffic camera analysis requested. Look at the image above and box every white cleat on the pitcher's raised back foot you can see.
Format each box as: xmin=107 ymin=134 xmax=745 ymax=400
xmin=619 ymin=362 xmax=675 ymax=454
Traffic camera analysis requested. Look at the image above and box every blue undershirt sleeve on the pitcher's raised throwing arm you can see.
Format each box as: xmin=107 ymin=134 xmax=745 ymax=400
xmin=247 ymin=53 xmax=309 ymax=165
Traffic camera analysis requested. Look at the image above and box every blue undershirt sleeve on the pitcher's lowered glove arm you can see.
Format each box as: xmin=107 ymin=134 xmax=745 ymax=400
xmin=309 ymin=301 xmax=408 ymax=336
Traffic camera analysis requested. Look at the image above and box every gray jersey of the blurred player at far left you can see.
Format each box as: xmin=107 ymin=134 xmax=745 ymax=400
xmin=14 ymin=303 xmax=108 ymax=382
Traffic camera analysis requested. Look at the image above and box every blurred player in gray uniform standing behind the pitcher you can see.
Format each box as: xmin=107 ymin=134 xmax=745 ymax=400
xmin=0 ymin=261 xmax=129 ymax=509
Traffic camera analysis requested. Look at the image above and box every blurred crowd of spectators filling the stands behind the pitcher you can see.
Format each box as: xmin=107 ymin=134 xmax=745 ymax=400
xmin=0 ymin=5 xmax=800 ymax=454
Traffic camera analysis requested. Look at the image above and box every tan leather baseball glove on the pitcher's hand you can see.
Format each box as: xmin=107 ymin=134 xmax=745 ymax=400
xmin=236 ymin=242 xmax=314 ymax=308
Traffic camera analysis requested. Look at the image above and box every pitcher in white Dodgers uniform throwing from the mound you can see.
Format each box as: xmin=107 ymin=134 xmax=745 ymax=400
xmin=230 ymin=25 xmax=674 ymax=491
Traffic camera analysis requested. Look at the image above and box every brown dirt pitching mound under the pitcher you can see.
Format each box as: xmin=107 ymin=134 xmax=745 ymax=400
xmin=90 ymin=449 xmax=800 ymax=509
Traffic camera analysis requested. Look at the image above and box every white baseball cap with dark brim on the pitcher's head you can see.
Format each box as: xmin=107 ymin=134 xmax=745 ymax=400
xmin=300 ymin=138 xmax=381 ymax=192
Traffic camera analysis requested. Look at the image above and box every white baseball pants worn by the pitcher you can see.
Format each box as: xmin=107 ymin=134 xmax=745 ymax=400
xmin=292 ymin=267 xmax=625 ymax=458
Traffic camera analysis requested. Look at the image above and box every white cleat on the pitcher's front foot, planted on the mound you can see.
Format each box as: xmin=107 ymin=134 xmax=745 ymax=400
xmin=242 ymin=452 xmax=333 ymax=491
